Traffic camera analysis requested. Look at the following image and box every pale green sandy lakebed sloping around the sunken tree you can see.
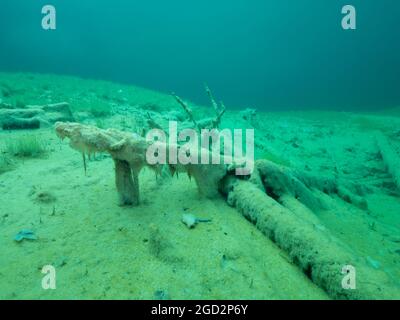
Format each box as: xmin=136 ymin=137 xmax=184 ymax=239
xmin=0 ymin=74 xmax=400 ymax=299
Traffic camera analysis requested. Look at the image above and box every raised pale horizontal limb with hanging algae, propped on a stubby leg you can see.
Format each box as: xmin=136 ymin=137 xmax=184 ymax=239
xmin=55 ymin=122 xmax=228 ymax=205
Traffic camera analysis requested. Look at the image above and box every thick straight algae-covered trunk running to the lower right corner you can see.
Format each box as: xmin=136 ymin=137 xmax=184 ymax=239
xmin=224 ymin=178 xmax=400 ymax=299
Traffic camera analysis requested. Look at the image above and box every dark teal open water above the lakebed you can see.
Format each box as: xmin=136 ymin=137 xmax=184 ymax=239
xmin=0 ymin=0 xmax=400 ymax=110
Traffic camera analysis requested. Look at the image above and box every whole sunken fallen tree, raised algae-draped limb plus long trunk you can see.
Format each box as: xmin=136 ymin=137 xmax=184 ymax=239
xmin=55 ymin=123 xmax=400 ymax=299
